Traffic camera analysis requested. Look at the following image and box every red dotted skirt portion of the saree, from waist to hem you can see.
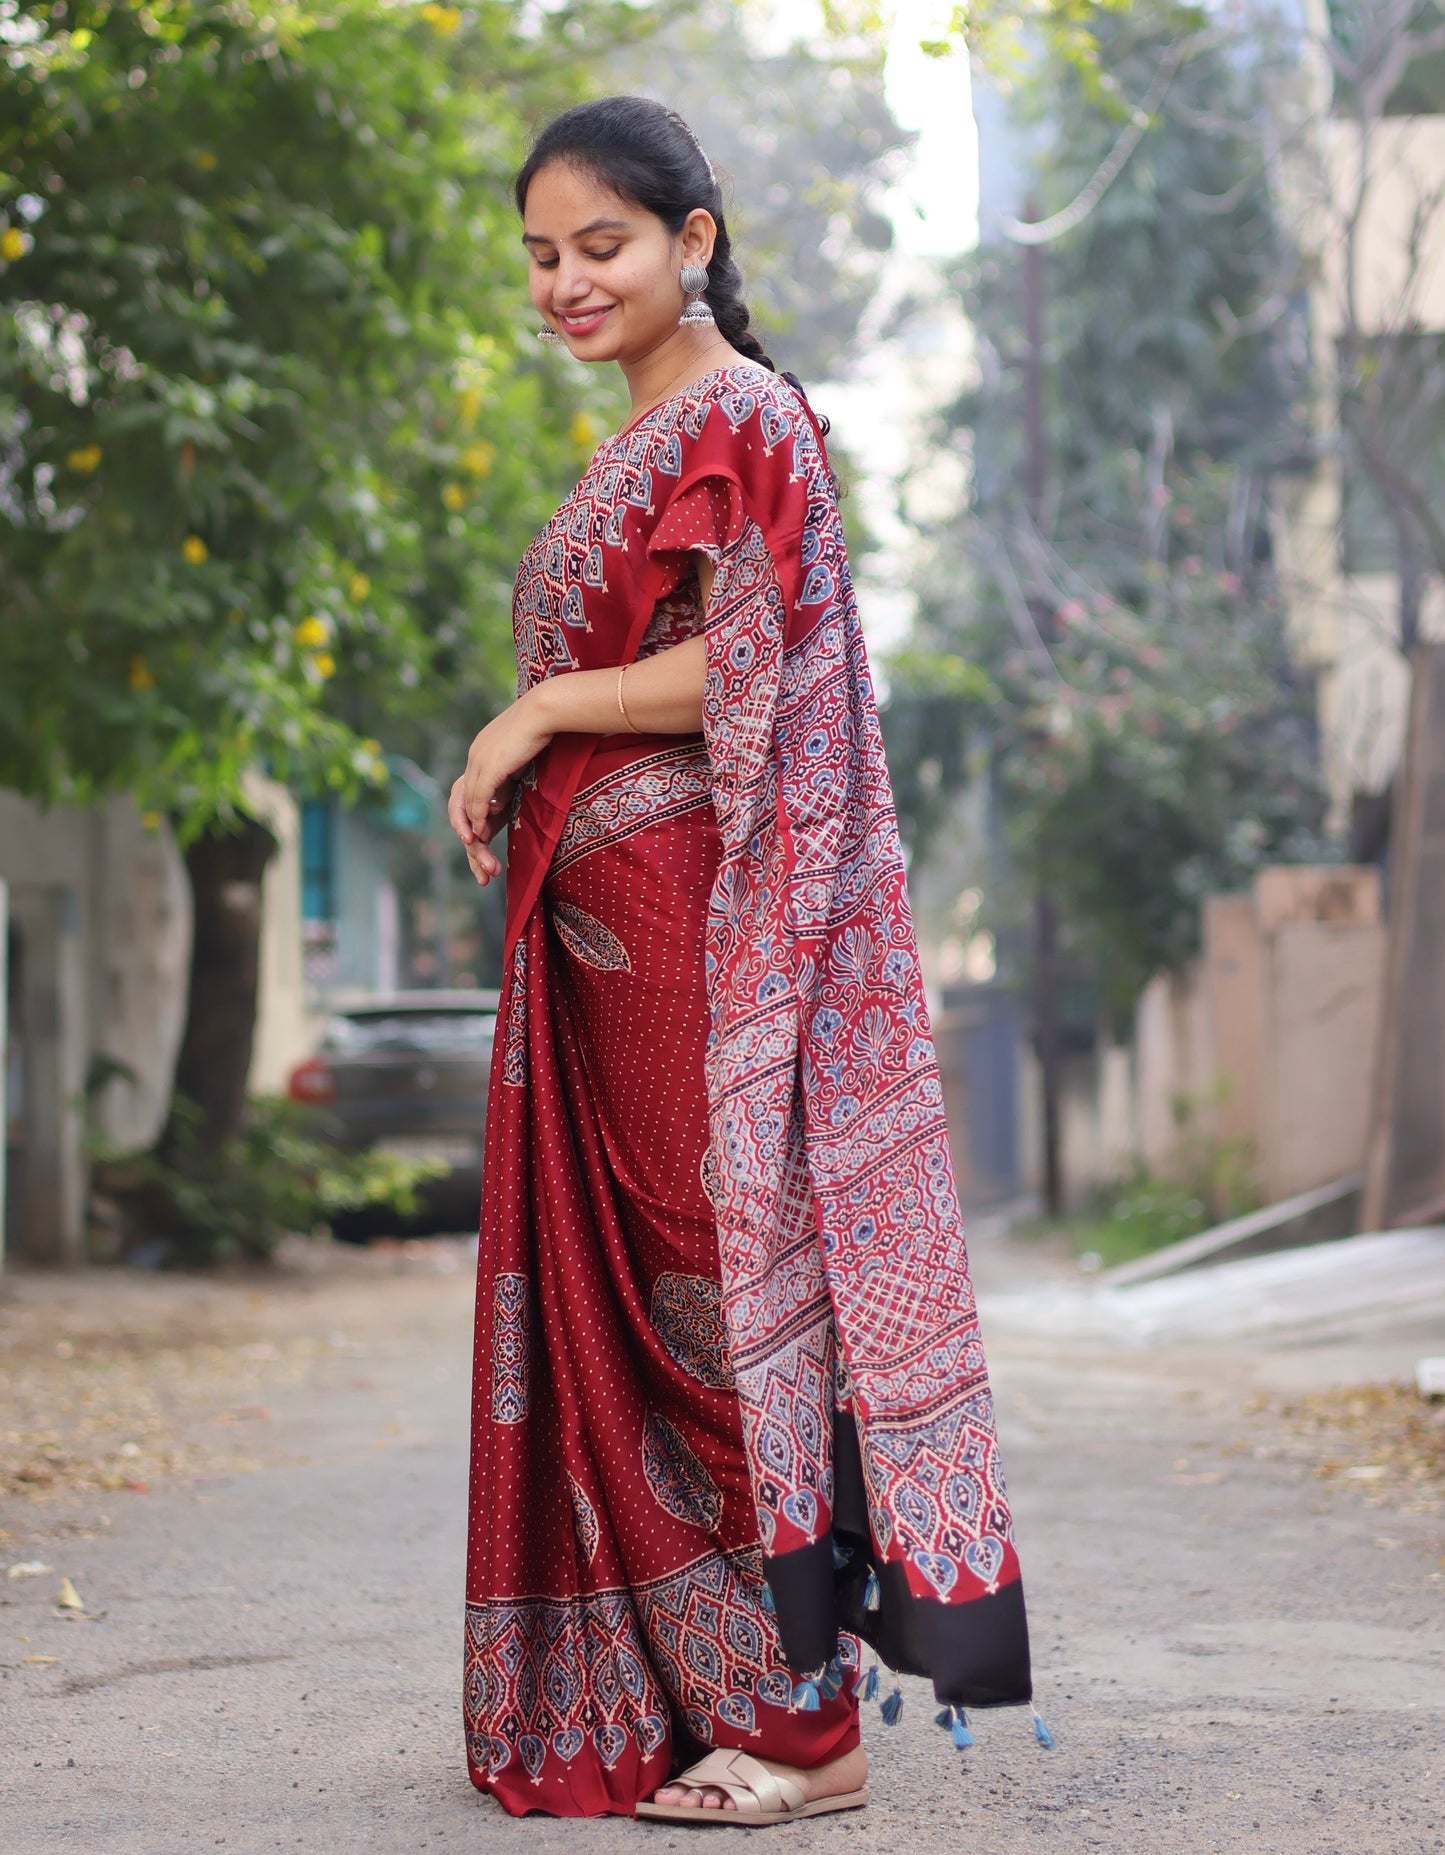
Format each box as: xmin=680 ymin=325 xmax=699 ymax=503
xmin=464 ymin=740 xmax=857 ymax=1816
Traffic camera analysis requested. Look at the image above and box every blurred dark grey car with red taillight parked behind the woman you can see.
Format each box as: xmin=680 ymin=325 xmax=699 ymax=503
xmin=288 ymin=991 xmax=499 ymax=1241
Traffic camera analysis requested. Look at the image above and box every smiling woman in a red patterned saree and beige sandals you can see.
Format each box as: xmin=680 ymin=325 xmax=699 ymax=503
xmin=451 ymin=96 xmax=1029 ymax=1822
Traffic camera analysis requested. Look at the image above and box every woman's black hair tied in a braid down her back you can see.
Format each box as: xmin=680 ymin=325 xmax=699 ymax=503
xmin=516 ymin=96 xmax=827 ymax=430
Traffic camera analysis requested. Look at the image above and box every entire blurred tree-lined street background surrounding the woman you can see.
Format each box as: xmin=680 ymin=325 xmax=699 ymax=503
xmin=0 ymin=0 xmax=1445 ymax=1855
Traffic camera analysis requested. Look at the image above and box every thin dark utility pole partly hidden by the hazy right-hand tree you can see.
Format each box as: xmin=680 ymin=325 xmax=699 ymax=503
xmin=1024 ymin=200 xmax=1063 ymax=1217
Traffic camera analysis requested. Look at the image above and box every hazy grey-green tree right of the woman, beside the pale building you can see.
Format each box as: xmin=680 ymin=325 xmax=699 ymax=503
xmin=890 ymin=6 xmax=1323 ymax=1022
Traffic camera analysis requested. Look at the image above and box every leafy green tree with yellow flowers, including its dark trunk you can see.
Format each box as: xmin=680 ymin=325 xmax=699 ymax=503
xmin=0 ymin=0 xmax=647 ymax=1179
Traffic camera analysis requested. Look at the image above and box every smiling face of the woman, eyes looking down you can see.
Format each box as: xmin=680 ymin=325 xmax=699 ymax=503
xmin=521 ymin=161 xmax=716 ymax=364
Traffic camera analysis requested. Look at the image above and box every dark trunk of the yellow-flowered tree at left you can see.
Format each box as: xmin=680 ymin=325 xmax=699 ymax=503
xmin=160 ymin=818 xmax=276 ymax=1159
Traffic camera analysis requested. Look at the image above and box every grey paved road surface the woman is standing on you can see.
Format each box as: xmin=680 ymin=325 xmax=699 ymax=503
xmin=0 ymin=1237 xmax=1445 ymax=1855
